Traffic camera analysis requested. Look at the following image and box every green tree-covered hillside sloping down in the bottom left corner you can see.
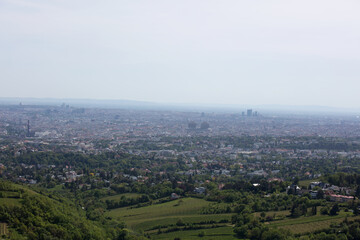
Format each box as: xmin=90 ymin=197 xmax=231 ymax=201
xmin=0 ymin=181 xmax=140 ymax=239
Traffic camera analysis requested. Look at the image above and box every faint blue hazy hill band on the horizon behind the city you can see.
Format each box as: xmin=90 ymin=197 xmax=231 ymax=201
xmin=0 ymin=98 xmax=360 ymax=115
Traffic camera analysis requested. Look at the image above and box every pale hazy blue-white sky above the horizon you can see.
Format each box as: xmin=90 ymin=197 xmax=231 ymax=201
xmin=0 ymin=0 xmax=360 ymax=108
